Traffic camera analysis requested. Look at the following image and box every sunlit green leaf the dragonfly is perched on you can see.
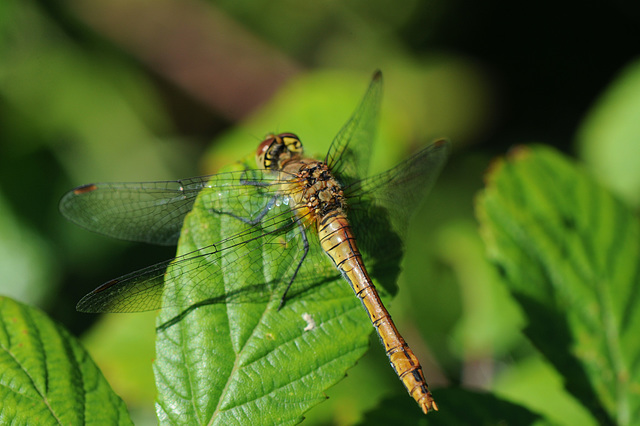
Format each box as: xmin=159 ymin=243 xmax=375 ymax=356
xmin=154 ymin=164 xmax=372 ymax=425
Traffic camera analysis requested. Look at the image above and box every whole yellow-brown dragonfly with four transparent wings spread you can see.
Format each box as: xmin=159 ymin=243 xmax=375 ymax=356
xmin=60 ymin=71 xmax=449 ymax=414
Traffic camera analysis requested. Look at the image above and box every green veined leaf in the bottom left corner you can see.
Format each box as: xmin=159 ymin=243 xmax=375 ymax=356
xmin=0 ymin=297 xmax=131 ymax=425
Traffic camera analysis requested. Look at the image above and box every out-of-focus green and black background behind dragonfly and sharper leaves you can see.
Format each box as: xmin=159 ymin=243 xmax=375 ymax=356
xmin=0 ymin=0 xmax=640 ymax=424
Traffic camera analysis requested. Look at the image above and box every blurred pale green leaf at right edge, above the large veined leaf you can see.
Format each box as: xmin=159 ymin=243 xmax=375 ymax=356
xmin=577 ymin=60 xmax=640 ymax=207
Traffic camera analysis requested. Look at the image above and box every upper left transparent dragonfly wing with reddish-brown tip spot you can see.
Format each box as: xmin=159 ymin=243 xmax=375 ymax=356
xmin=60 ymin=170 xmax=290 ymax=245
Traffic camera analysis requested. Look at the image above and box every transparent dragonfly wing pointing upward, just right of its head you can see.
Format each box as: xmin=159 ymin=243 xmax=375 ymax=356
xmin=325 ymin=71 xmax=382 ymax=186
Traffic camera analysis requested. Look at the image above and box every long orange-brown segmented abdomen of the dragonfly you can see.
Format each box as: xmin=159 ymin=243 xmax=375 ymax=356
xmin=318 ymin=213 xmax=438 ymax=414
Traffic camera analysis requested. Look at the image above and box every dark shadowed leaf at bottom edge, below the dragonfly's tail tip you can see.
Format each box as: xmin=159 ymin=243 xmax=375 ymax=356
xmin=360 ymin=389 xmax=543 ymax=426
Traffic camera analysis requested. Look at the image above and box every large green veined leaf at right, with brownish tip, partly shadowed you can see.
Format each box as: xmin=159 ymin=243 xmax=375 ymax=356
xmin=477 ymin=147 xmax=640 ymax=424
